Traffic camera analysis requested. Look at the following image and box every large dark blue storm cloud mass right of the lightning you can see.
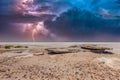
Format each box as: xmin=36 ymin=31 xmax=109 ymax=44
xmin=46 ymin=8 xmax=120 ymax=41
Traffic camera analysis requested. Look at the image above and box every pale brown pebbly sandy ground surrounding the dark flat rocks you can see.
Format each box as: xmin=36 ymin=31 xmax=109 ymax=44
xmin=0 ymin=43 xmax=120 ymax=80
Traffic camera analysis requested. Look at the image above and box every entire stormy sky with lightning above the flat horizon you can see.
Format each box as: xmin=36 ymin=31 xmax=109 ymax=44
xmin=0 ymin=0 xmax=120 ymax=42
